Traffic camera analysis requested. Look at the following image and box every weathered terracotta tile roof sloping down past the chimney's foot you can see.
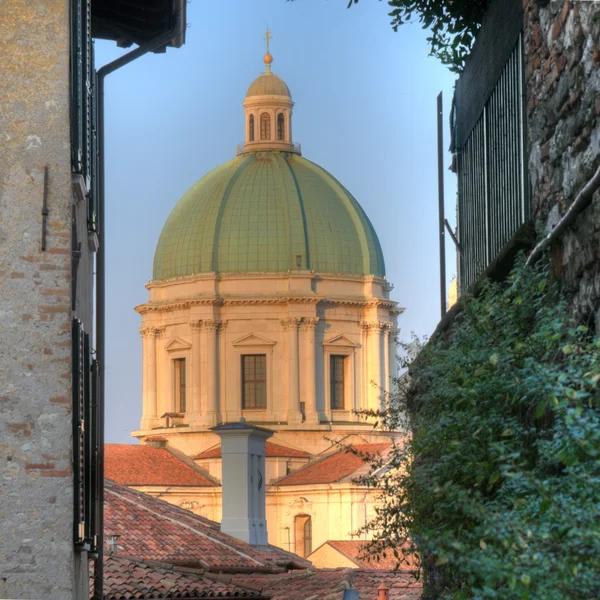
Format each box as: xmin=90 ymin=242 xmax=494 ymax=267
xmin=104 ymin=480 xmax=310 ymax=573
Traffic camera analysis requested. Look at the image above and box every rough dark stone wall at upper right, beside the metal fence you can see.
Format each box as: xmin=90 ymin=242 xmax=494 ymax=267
xmin=523 ymin=0 xmax=600 ymax=331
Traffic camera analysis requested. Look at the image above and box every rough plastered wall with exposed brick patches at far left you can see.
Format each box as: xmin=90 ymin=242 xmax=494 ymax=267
xmin=0 ymin=0 xmax=81 ymax=599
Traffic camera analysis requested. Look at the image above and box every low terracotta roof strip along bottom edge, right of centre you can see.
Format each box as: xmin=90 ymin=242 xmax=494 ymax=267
xmin=226 ymin=569 xmax=422 ymax=600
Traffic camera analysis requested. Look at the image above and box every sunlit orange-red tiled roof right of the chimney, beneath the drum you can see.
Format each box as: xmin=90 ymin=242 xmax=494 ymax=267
xmin=275 ymin=442 xmax=391 ymax=485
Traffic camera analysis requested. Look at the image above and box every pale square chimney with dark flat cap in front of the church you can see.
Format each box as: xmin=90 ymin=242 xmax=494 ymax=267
xmin=211 ymin=417 xmax=273 ymax=546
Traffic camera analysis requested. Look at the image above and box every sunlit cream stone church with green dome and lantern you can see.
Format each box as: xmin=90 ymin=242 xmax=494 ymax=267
xmin=133 ymin=32 xmax=402 ymax=556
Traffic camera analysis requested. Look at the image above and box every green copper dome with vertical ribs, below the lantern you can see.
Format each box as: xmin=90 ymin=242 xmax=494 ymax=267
xmin=154 ymin=151 xmax=385 ymax=280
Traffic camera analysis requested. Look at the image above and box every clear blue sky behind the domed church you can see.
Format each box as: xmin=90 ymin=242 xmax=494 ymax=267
xmin=96 ymin=0 xmax=456 ymax=443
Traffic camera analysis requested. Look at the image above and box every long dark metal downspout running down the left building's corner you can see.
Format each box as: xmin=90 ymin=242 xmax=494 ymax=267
xmin=94 ymin=9 xmax=183 ymax=600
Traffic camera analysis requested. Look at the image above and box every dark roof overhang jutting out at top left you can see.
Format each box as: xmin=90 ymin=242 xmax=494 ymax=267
xmin=92 ymin=0 xmax=186 ymax=52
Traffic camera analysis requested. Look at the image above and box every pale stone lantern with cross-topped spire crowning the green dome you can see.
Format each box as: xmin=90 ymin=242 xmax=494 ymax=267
xmin=242 ymin=28 xmax=300 ymax=154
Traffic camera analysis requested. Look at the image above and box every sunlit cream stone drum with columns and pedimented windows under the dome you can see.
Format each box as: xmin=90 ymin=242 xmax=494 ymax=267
xmin=134 ymin=272 xmax=398 ymax=455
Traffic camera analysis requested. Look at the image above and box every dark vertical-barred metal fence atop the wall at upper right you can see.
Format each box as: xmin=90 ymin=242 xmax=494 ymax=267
xmin=457 ymin=36 xmax=530 ymax=292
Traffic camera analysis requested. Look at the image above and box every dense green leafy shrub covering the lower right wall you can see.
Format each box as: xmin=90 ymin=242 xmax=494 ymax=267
xmin=354 ymin=264 xmax=600 ymax=600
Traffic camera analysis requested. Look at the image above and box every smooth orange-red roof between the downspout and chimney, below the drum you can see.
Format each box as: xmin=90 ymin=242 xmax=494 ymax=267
xmin=104 ymin=444 xmax=216 ymax=487
